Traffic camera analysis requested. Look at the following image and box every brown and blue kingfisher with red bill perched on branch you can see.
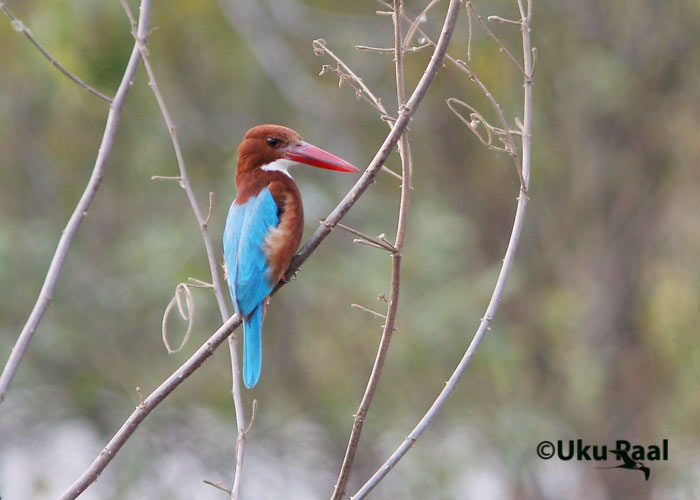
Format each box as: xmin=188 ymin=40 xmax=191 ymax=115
xmin=223 ymin=125 xmax=359 ymax=389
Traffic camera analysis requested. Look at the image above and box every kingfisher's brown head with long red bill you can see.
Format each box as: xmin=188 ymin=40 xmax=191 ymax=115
xmin=237 ymin=125 xmax=359 ymax=175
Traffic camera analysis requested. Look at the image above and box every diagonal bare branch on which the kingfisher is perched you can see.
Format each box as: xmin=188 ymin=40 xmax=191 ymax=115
xmin=59 ymin=0 xmax=459 ymax=494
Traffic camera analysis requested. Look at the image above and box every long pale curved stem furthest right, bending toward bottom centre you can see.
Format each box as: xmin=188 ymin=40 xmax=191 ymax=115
xmin=352 ymin=0 xmax=532 ymax=500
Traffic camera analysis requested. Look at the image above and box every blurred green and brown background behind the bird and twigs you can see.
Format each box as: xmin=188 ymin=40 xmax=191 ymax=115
xmin=0 ymin=0 xmax=700 ymax=500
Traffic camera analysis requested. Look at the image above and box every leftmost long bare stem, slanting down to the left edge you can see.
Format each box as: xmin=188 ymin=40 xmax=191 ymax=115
xmin=0 ymin=0 xmax=151 ymax=401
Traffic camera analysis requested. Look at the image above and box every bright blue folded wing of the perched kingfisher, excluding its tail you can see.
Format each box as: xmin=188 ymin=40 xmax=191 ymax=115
xmin=224 ymin=188 xmax=279 ymax=316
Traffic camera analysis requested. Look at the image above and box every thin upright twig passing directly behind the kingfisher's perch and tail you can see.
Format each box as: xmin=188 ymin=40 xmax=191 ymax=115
xmin=121 ymin=0 xmax=246 ymax=500
